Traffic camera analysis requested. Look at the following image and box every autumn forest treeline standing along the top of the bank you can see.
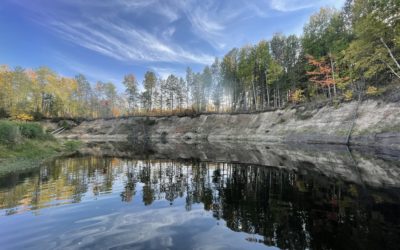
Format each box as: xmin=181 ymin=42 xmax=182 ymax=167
xmin=0 ymin=0 xmax=400 ymax=119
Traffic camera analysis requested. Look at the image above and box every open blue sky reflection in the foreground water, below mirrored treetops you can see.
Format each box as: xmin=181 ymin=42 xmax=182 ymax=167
xmin=0 ymin=188 xmax=276 ymax=249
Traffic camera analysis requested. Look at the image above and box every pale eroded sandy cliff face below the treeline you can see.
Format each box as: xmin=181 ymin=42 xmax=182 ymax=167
xmin=61 ymin=100 xmax=400 ymax=148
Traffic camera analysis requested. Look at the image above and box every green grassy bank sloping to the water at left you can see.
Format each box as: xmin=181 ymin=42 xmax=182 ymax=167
xmin=0 ymin=120 xmax=80 ymax=173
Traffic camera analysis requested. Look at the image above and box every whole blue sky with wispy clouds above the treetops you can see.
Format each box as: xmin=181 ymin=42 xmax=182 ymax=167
xmin=0 ymin=0 xmax=344 ymax=89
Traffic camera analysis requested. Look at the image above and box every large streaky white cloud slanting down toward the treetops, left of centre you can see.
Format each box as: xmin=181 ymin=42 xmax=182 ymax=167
xmin=47 ymin=18 xmax=214 ymax=64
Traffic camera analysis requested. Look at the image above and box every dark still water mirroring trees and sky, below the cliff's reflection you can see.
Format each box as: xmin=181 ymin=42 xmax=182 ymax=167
xmin=0 ymin=144 xmax=400 ymax=249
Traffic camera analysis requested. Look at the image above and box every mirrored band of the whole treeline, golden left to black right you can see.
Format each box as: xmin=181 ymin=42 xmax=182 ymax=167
xmin=0 ymin=156 xmax=400 ymax=249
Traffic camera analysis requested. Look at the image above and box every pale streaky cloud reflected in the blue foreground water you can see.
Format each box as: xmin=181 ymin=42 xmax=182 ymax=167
xmin=52 ymin=208 xmax=197 ymax=249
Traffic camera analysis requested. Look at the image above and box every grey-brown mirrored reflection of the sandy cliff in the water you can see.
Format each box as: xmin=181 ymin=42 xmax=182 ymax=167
xmin=80 ymin=142 xmax=400 ymax=187
